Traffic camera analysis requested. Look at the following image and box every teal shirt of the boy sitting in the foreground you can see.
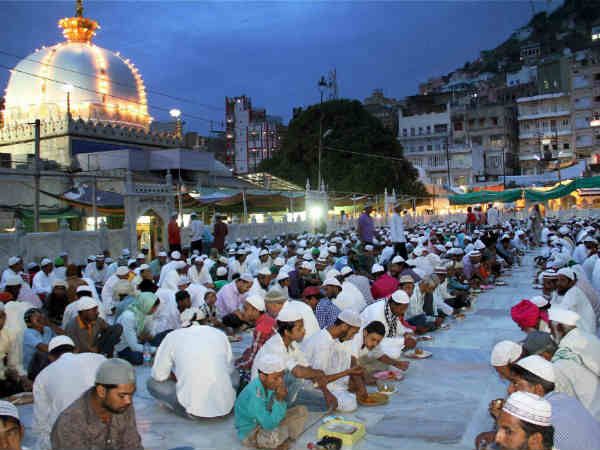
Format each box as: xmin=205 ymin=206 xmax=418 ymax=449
xmin=235 ymin=377 xmax=287 ymax=440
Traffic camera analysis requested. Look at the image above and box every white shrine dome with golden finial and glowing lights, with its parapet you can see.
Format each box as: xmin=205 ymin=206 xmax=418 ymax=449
xmin=0 ymin=0 xmax=181 ymax=166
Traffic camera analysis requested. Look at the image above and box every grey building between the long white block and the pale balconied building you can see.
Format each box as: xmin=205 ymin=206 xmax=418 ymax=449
xmin=450 ymin=98 xmax=518 ymax=181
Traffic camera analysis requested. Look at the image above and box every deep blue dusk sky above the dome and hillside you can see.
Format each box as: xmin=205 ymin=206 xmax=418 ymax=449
xmin=0 ymin=0 xmax=556 ymax=131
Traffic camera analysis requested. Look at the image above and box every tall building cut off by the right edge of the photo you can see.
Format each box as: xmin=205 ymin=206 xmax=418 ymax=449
xmin=571 ymin=51 xmax=600 ymax=164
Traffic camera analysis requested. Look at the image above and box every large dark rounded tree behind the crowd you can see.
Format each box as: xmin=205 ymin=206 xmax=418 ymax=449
xmin=261 ymin=100 xmax=426 ymax=195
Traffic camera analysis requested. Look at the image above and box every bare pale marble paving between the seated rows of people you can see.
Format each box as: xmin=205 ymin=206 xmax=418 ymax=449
xmin=21 ymin=256 xmax=534 ymax=450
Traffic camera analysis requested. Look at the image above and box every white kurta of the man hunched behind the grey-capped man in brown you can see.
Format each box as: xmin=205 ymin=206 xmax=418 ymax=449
xmin=32 ymin=341 xmax=106 ymax=450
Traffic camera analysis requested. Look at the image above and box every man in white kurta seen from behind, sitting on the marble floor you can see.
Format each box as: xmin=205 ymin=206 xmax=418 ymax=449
xmin=148 ymin=308 xmax=235 ymax=418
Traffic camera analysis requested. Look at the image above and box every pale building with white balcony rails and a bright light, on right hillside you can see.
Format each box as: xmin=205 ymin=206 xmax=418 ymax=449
xmin=517 ymin=92 xmax=574 ymax=174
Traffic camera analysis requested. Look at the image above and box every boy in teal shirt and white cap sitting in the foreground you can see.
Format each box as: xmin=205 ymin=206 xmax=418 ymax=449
xmin=235 ymin=355 xmax=308 ymax=449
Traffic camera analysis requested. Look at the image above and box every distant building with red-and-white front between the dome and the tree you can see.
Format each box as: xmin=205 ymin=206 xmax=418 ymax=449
xmin=224 ymin=95 xmax=281 ymax=174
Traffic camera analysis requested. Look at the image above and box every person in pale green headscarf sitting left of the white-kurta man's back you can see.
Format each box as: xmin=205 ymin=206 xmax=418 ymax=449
xmin=115 ymin=292 xmax=160 ymax=366
